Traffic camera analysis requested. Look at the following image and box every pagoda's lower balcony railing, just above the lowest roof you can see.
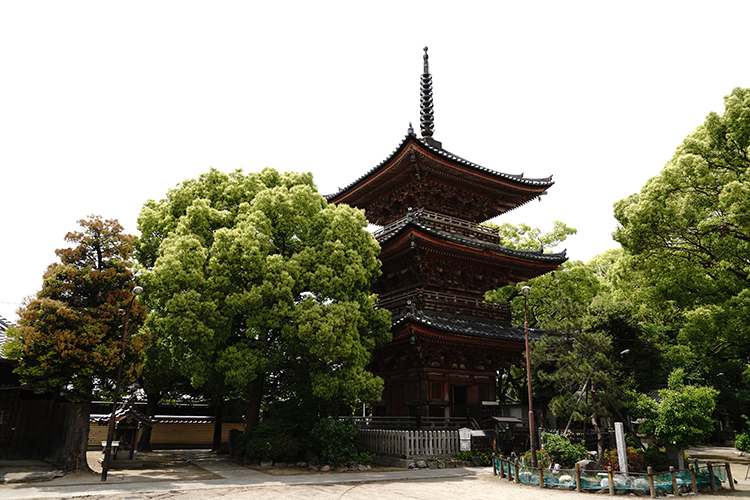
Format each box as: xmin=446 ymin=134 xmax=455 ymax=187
xmin=378 ymin=288 xmax=510 ymax=321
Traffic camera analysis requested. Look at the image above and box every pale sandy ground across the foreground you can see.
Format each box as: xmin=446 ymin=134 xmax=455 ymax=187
xmin=0 ymin=447 xmax=750 ymax=500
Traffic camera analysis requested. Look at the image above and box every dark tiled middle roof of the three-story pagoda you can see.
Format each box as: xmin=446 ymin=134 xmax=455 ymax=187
xmin=376 ymin=212 xmax=567 ymax=265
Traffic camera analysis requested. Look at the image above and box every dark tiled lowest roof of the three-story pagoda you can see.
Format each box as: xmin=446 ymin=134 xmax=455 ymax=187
xmin=392 ymin=310 xmax=543 ymax=342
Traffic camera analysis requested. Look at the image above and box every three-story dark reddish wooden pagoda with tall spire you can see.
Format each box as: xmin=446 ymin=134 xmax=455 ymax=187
xmin=328 ymin=47 xmax=566 ymax=420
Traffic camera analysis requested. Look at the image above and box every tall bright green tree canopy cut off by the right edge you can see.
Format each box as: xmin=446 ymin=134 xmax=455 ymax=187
xmin=614 ymin=88 xmax=750 ymax=332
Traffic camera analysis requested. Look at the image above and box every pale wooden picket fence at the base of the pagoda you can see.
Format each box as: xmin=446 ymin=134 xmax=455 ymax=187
xmin=359 ymin=428 xmax=459 ymax=458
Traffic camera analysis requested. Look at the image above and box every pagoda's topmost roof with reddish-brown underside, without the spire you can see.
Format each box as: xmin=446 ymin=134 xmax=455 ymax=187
xmin=326 ymin=133 xmax=554 ymax=225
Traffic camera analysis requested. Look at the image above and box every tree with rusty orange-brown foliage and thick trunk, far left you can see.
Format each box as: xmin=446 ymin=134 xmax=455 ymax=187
xmin=5 ymin=216 xmax=146 ymax=470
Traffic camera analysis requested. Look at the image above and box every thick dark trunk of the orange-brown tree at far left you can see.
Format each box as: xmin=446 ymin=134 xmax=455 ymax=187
xmin=49 ymin=401 xmax=93 ymax=472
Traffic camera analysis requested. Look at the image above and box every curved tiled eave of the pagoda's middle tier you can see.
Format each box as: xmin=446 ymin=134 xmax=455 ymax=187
xmin=378 ymin=221 xmax=568 ymax=265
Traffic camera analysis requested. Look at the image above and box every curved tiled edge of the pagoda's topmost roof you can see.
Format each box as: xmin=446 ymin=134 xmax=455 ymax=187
xmin=325 ymin=134 xmax=554 ymax=206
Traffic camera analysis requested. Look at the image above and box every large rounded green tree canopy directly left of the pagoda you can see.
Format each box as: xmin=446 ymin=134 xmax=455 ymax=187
xmin=138 ymin=169 xmax=390 ymax=427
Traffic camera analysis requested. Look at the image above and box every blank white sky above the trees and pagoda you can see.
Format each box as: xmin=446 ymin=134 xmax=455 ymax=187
xmin=0 ymin=0 xmax=750 ymax=320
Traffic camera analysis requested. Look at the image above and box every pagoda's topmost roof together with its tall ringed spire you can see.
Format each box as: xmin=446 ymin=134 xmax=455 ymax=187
xmin=326 ymin=47 xmax=553 ymax=226
